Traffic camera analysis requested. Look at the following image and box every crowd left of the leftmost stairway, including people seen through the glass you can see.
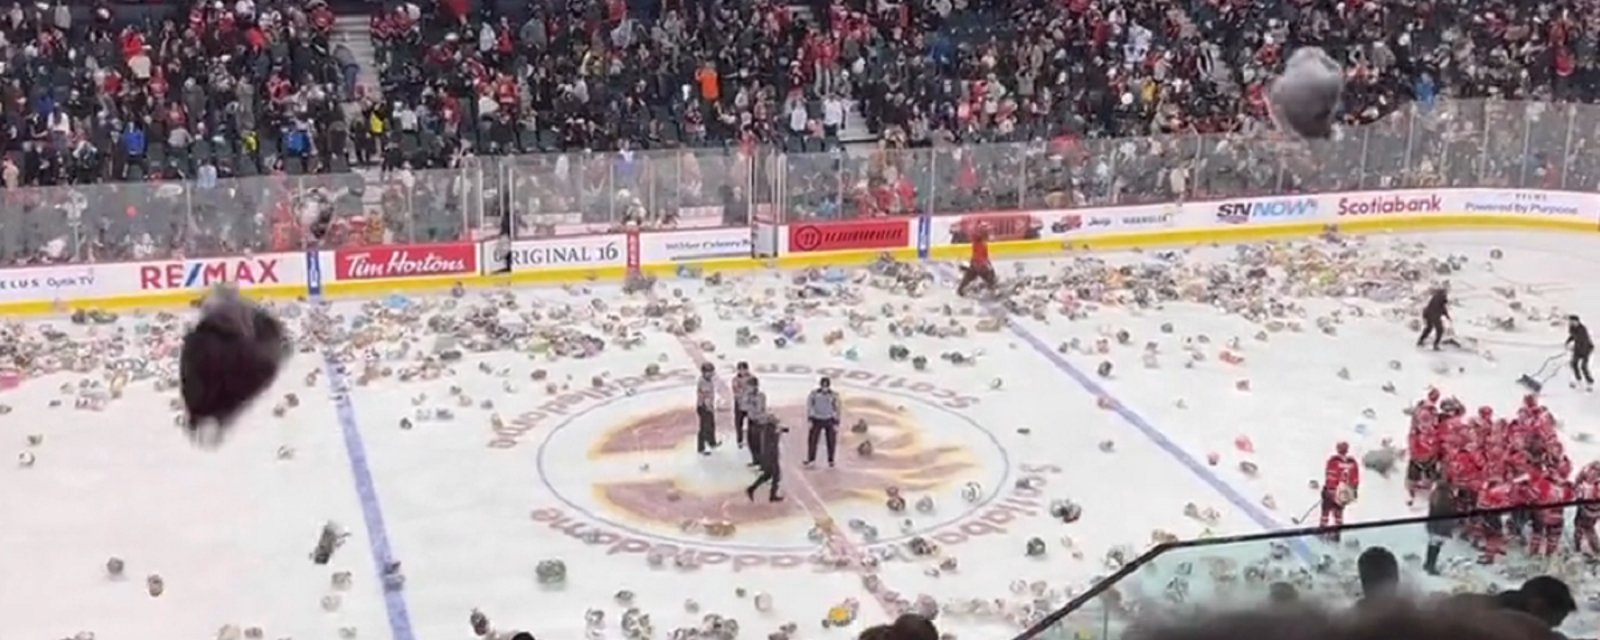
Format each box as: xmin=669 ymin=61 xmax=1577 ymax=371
xmin=0 ymin=0 xmax=368 ymax=262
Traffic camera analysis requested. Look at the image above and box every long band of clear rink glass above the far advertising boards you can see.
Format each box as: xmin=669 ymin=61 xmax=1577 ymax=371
xmin=0 ymin=101 xmax=1600 ymax=264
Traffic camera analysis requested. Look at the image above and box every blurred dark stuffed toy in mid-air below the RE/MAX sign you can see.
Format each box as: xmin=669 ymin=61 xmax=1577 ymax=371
xmin=178 ymin=288 xmax=290 ymax=443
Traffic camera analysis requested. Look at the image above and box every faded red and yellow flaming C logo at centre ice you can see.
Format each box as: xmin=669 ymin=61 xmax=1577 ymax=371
xmin=590 ymin=397 xmax=974 ymax=525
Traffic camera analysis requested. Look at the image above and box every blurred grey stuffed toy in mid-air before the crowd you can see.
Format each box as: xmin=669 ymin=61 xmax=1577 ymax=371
xmin=1267 ymin=46 xmax=1344 ymax=139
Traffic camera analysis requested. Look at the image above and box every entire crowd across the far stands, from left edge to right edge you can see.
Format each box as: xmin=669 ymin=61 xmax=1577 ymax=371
xmin=0 ymin=0 xmax=1600 ymax=258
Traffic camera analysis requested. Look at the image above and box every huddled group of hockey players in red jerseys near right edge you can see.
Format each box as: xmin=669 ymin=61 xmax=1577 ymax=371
xmin=1401 ymin=389 xmax=1600 ymax=573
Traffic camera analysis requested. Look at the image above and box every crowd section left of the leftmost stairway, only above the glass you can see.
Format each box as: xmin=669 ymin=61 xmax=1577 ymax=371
xmin=0 ymin=0 xmax=347 ymax=189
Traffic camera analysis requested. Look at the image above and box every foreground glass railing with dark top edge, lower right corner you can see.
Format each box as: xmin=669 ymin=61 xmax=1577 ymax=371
xmin=1016 ymin=501 xmax=1600 ymax=640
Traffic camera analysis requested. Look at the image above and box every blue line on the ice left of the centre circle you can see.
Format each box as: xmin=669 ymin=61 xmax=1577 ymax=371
xmin=309 ymin=268 xmax=416 ymax=640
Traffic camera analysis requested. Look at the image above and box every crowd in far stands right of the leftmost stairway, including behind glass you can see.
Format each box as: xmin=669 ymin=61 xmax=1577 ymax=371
xmin=353 ymin=0 xmax=1600 ymax=227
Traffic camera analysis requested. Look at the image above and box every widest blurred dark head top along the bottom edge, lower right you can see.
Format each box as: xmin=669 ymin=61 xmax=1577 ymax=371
xmin=1120 ymin=598 xmax=1550 ymax=640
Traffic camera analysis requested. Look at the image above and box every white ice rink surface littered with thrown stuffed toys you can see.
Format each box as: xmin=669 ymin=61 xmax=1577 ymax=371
xmin=0 ymin=232 xmax=1600 ymax=640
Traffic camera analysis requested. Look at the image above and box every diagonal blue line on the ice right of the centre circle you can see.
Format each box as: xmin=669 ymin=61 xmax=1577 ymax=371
xmin=933 ymin=264 xmax=1317 ymax=563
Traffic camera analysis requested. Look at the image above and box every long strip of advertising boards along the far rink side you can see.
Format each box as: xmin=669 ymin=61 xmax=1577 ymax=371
xmin=0 ymin=189 xmax=1600 ymax=312
